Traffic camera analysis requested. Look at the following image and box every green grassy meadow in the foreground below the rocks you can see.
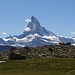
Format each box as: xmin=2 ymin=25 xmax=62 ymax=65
xmin=0 ymin=58 xmax=75 ymax=75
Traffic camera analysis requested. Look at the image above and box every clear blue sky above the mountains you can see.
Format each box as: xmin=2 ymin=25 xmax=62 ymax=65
xmin=0 ymin=0 xmax=75 ymax=38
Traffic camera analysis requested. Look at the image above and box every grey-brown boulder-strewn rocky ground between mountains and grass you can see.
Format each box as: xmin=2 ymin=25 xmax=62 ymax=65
xmin=0 ymin=45 xmax=75 ymax=60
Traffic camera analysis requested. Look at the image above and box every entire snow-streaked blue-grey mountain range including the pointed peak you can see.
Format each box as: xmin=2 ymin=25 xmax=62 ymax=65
xmin=0 ymin=16 xmax=75 ymax=47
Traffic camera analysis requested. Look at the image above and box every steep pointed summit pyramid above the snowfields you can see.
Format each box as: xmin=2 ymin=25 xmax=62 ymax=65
xmin=24 ymin=16 xmax=57 ymax=36
